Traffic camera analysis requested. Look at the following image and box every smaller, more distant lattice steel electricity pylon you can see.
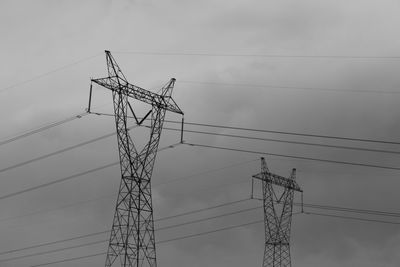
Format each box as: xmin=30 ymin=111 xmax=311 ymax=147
xmin=253 ymin=158 xmax=303 ymax=267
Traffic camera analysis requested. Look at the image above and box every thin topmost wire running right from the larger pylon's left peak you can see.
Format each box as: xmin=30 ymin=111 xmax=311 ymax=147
xmin=114 ymin=51 xmax=400 ymax=60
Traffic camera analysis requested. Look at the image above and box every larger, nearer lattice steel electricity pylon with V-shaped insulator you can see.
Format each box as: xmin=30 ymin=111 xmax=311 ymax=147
xmin=88 ymin=51 xmax=183 ymax=267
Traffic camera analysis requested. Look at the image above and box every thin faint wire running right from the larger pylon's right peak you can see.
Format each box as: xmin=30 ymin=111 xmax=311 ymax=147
xmin=179 ymin=80 xmax=400 ymax=94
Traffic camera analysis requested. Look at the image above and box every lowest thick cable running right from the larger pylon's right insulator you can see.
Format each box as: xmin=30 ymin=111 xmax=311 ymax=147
xmin=184 ymin=142 xmax=400 ymax=171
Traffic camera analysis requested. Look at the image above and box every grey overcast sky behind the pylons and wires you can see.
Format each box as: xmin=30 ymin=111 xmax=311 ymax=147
xmin=0 ymin=0 xmax=400 ymax=267
